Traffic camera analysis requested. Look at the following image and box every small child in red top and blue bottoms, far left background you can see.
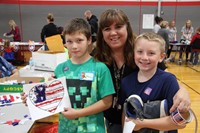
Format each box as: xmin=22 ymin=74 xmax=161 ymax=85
xmin=3 ymin=39 xmax=15 ymax=63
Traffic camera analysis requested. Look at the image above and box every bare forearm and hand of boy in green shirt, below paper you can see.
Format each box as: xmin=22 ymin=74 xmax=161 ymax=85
xmin=62 ymin=95 xmax=112 ymax=119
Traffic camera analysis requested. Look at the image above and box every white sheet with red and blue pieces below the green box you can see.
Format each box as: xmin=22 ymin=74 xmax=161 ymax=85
xmin=0 ymin=93 xmax=22 ymax=106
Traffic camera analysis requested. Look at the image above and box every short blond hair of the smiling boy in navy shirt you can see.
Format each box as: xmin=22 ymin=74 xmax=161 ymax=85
xmin=135 ymin=32 xmax=165 ymax=53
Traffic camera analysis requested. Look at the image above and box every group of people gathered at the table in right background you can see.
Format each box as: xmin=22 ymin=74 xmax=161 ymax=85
xmin=153 ymin=16 xmax=200 ymax=65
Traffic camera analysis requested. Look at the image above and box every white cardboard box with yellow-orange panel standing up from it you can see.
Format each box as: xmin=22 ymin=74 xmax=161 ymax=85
xmin=32 ymin=35 xmax=67 ymax=71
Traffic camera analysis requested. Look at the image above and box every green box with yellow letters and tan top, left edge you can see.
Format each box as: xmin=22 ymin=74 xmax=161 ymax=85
xmin=0 ymin=77 xmax=44 ymax=93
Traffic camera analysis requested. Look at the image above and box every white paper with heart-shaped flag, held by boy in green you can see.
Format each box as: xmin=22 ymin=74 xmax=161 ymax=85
xmin=23 ymin=77 xmax=71 ymax=121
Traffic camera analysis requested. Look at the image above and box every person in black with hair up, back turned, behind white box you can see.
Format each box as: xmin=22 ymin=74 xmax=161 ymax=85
xmin=41 ymin=13 xmax=58 ymax=50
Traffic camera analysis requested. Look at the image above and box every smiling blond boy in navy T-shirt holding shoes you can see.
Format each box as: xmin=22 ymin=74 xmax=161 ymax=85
xmin=121 ymin=33 xmax=184 ymax=133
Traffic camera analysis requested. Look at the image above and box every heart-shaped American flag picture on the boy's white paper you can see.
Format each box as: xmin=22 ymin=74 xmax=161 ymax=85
xmin=29 ymin=80 xmax=64 ymax=113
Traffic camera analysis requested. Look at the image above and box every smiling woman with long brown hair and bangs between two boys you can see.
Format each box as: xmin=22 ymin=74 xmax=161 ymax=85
xmin=94 ymin=9 xmax=190 ymax=133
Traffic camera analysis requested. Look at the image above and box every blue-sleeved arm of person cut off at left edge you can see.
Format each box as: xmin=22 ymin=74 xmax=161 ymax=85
xmin=0 ymin=56 xmax=18 ymax=78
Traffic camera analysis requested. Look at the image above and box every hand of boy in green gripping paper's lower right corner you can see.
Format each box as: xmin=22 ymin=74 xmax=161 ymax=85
xmin=62 ymin=108 xmax=79 ymax=120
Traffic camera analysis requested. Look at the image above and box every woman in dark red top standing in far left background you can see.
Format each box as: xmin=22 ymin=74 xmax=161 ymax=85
xmin=3 ymin=19 xmax=21 ymax=42
